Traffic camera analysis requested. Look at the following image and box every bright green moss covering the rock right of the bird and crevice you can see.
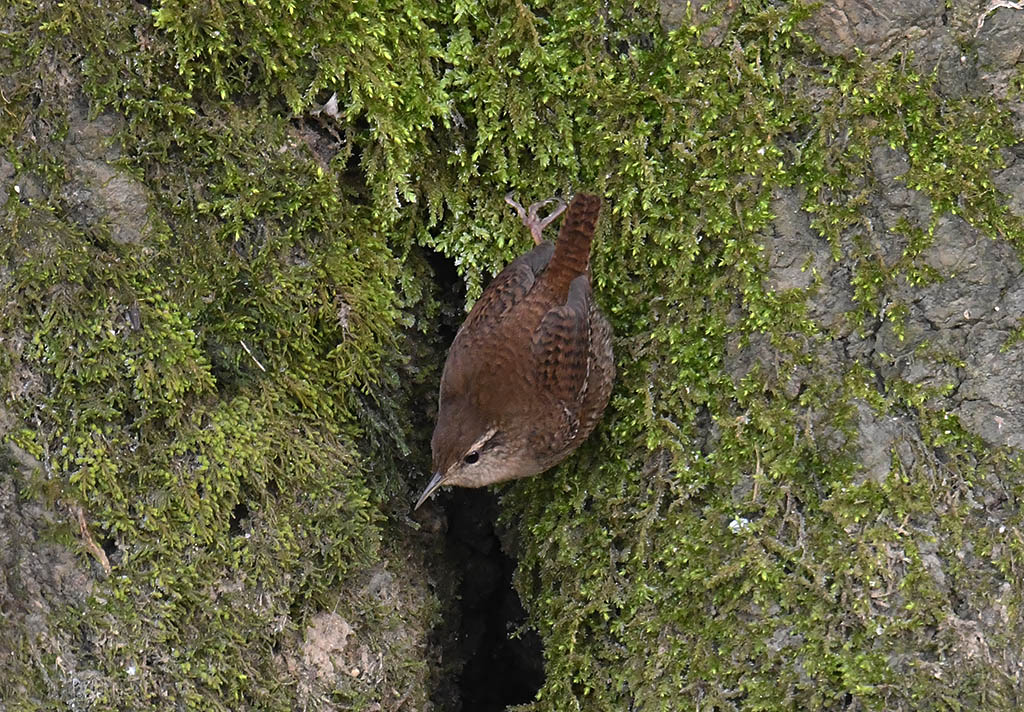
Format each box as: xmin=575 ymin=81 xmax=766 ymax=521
xmin=487 ymin=1 xmax=1021 ymax=710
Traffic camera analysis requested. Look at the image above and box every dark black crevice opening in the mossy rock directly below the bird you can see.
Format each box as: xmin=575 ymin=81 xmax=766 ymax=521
xmin=446 ymin=488 xmax=544 ymax=712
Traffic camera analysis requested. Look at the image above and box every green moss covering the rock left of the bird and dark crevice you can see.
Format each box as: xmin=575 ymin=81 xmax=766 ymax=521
xmin=2 ymin=5 xmax=437 ymax=710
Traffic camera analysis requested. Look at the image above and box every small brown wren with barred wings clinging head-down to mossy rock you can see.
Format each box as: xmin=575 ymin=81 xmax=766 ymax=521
xmin=416 ymin=194 xmax=615 ymax=508
